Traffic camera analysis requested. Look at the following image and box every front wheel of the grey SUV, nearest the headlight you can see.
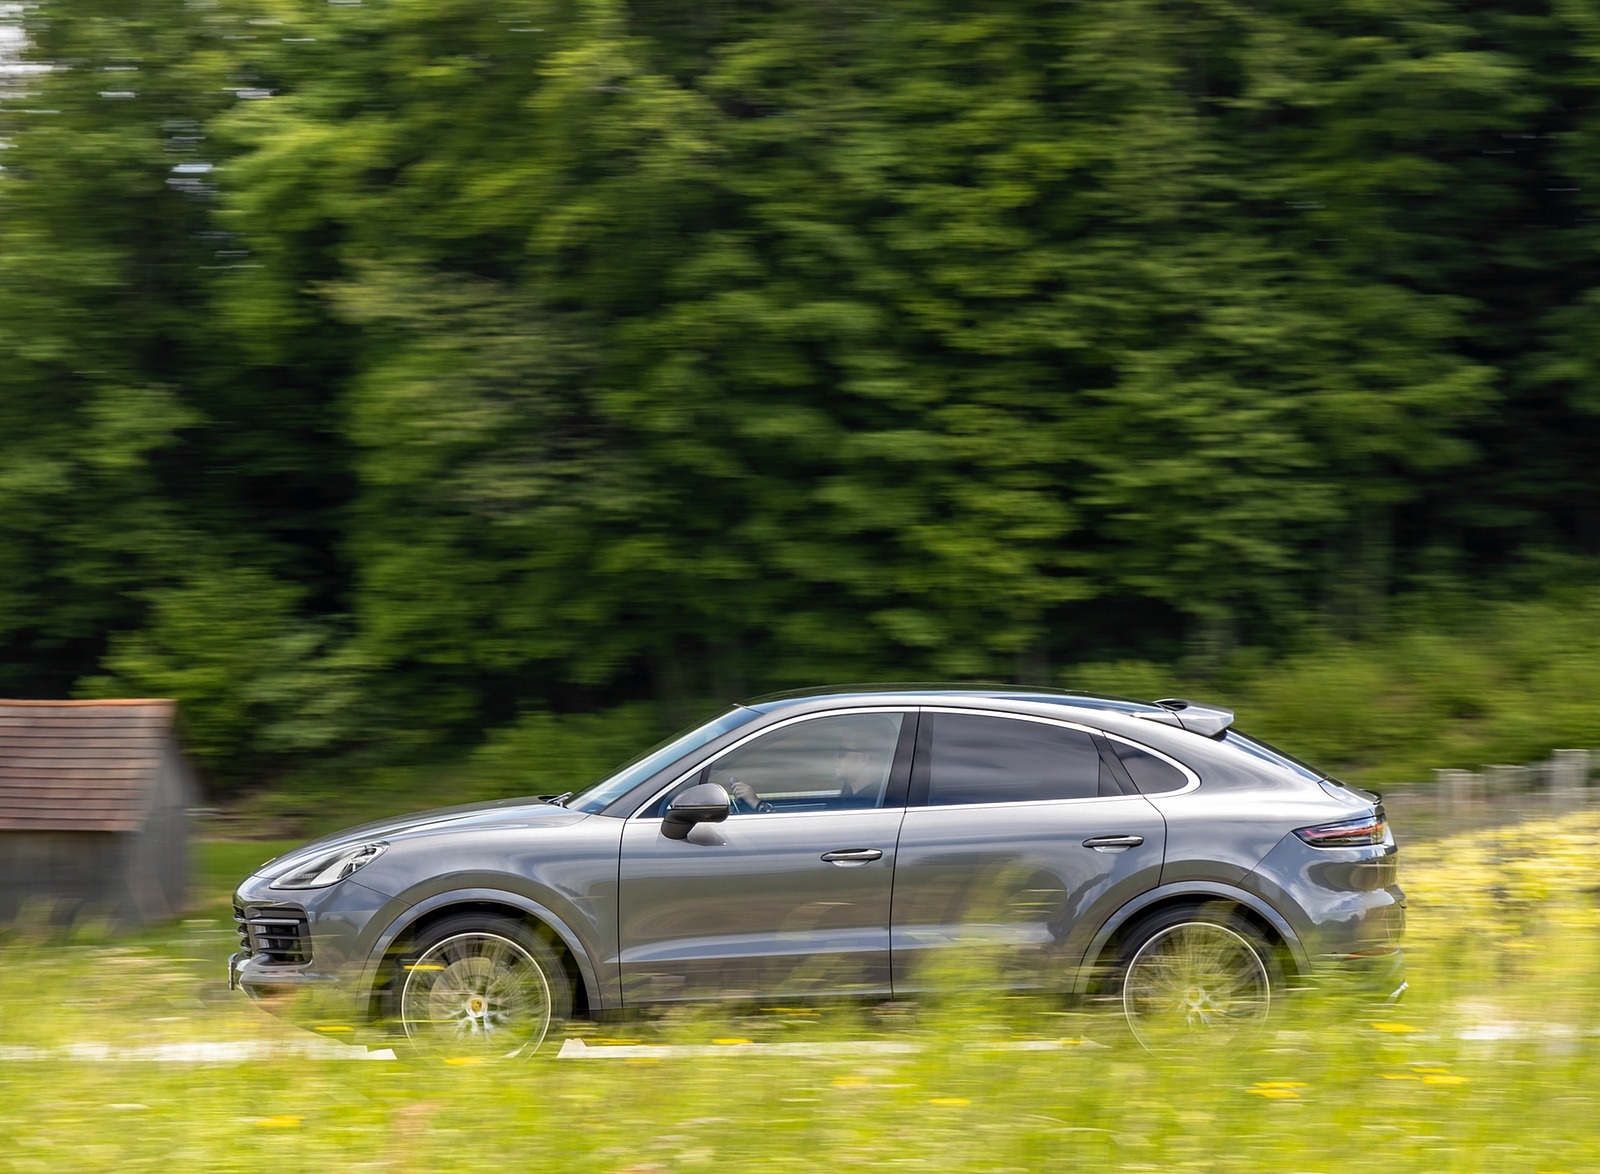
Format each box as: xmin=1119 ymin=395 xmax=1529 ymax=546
xmin=397 ymin=913 xmax=573 ymax=1059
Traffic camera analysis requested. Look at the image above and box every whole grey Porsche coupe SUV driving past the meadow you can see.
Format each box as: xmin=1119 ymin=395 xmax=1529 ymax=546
xmin=229 ymin=686 xmax=1405 ymax=1054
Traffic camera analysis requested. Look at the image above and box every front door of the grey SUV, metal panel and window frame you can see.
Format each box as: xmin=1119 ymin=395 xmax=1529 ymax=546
xmin=618 ymin=710 xmax=914 ymax=1006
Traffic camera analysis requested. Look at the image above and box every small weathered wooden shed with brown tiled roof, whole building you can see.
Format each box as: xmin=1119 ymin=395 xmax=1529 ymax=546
xmin=0 ymin=701 xmax=198 ymax=924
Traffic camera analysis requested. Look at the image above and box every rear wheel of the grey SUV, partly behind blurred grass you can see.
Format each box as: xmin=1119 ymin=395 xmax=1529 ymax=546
xmin=1117 ymin=907 xmax=1283 ymax=1051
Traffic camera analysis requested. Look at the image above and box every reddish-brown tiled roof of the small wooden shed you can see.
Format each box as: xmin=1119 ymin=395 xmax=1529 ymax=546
xmin=0 ymin=701 xmax=174 ymax=832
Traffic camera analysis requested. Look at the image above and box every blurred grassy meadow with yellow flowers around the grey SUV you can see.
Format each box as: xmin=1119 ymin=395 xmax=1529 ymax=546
xmin=0 ymin=814 xmax=1600 ymax=1174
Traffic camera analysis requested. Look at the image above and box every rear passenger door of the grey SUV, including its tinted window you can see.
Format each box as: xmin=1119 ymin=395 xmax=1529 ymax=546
xmin=891 ymin=710 xmax=1166 ymax=993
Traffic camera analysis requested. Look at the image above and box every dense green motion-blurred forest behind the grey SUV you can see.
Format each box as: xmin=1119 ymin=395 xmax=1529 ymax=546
xmin=0 ymin=0 xmax=1600 ymax=806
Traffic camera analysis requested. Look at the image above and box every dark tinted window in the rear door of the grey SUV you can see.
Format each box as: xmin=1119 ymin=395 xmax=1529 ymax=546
xmin=922 ymin=713 xmax=1101 ymax=805
